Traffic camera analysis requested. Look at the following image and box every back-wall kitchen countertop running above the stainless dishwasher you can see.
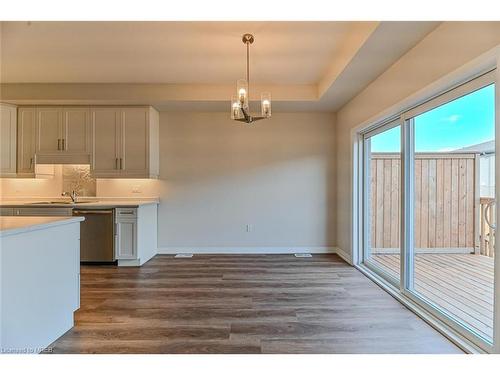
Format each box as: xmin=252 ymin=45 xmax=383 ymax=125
xmin=0 ymin=197 xmax=160 ymax=209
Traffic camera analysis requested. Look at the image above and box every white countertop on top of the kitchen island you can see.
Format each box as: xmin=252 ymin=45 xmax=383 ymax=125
xmin=0 ymin=216 xmax=85 ymax=237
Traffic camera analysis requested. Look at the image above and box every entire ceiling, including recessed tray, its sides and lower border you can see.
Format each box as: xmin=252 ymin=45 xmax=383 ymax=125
xmin=0 ymin=22 xmax=439 ymax=111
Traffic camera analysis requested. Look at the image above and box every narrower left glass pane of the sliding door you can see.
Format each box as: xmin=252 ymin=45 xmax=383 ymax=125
xmin=364 ymin=125 xmax=401 ymax=282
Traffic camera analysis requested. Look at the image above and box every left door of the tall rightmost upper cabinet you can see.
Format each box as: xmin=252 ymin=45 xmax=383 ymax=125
xmin=91 ymin=108 xmax=121 ymax=177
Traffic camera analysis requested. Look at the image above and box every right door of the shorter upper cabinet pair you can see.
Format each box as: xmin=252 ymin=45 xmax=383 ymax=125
xmin=62 ymin=107 xmax=91 ymax=154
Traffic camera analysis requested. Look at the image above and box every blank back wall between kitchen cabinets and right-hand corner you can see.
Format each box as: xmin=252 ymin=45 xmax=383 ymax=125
xmin=158 ymin=112 xmax=336 ymax=251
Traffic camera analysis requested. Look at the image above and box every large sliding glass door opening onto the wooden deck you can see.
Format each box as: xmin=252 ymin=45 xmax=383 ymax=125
xmin=359 ymin=72 xmax=500 ymax=351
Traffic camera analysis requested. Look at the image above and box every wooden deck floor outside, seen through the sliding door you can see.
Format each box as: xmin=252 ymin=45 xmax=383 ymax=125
xmin=372 ymin=254 xmax=493 ymax=338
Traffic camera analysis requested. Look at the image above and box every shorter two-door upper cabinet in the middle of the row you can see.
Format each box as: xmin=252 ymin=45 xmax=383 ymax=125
xmin=36 ymin=107 xmax=91 ymax=164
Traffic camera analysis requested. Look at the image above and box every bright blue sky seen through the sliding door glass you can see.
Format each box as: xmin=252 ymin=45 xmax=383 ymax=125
xmin=371 ymin=85 xmax=495 ymax=152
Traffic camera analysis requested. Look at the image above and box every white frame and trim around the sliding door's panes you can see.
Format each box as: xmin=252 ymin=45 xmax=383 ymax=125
xmin=352 ymin=46 xmax=500 ymax=353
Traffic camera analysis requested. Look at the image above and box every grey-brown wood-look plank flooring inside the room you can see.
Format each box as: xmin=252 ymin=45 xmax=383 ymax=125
xmin=51 ymin=255 xmax=460 ymax=353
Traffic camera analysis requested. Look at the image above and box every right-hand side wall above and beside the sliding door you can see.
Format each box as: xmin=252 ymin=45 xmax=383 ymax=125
xmin=336 ymin=22 xmax=500 ymax=253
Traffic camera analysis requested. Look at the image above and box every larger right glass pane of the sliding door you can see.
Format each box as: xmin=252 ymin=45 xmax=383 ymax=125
xmin=413 ymin=85 xmax=495 ymax=341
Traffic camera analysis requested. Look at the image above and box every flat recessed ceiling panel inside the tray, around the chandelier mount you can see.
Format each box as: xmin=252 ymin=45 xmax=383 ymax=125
xmin=2 ymin=22 xmax=353 ymax=84
